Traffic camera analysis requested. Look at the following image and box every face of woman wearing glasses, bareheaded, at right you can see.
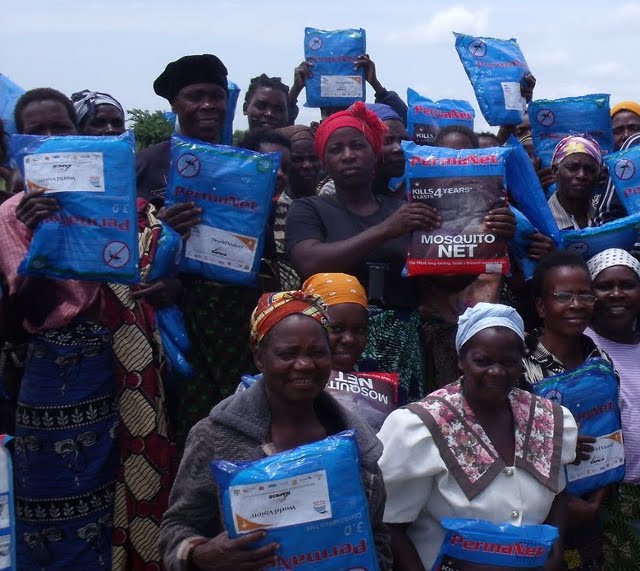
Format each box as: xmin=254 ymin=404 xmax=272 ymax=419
xmin=536 ymin=266 xmax=595 ymax=338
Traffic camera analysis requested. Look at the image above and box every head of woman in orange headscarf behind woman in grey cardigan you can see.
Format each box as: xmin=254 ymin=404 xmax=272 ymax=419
xmin=302 ymin=273 xmax=369 ymax=372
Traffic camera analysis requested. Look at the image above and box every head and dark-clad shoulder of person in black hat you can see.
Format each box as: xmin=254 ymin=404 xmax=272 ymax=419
xmin=136 ymin=54 xmax=228 ymax=207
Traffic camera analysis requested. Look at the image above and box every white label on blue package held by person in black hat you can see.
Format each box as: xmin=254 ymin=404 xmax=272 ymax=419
xmin=185 ymin=224 xmax=258 ymax=272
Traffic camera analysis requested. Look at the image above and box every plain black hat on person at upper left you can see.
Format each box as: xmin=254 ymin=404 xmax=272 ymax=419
xmin=153 ymin=54 xmax=228 ymax=103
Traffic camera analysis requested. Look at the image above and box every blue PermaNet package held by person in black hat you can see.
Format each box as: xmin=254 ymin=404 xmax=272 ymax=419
xmin=165 ymin=135 xmax=280 ymax=285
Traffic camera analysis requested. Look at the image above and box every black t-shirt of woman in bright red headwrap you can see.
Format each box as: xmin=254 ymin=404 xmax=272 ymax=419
xmin=285 ymin=195 xmax=418 ymax=307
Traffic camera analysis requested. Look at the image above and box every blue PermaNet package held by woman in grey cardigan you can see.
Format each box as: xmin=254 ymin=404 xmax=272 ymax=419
xmin=211 ymin=430 xmax=379 ymax=571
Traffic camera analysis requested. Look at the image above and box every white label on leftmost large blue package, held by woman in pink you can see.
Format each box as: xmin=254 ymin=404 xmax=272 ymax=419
xmin=24 ymin=153 xmax=104 ymax=192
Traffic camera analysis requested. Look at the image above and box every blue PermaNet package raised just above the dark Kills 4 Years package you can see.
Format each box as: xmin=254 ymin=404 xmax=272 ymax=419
xmin=407 ymin=89 xmax=476 ymax=145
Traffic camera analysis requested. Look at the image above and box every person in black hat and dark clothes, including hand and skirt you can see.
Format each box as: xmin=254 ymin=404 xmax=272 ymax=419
xmin=137 ymin=54 xmax=272 ymax=443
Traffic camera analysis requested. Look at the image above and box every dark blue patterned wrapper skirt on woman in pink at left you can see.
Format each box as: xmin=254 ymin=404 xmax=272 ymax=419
xmin=14 ymin=322 xmax=119 ymax=571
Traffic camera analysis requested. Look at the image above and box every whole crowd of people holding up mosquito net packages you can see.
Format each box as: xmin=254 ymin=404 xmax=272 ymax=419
xmin=0 ymin=50 xmax=640 ymax=571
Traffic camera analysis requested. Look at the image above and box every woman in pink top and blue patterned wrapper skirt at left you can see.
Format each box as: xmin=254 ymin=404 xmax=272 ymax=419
xmin=0 ymin=88 xmax=118 ymax=570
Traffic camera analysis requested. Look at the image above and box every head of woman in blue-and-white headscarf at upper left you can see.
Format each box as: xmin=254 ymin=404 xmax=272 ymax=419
xmin=71 ymin=89 xmax=126 ymax=137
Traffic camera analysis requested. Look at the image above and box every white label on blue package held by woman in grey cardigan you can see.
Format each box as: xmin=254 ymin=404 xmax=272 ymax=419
xmin=229 ymin=470 xmax=332 ymax=533
